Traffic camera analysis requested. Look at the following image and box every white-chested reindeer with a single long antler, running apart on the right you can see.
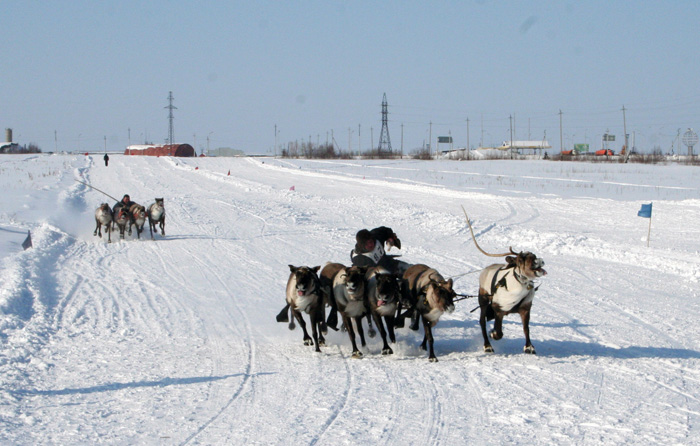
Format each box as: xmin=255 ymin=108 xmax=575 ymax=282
xmin=462 ymin=208 xmax=547 ymax=355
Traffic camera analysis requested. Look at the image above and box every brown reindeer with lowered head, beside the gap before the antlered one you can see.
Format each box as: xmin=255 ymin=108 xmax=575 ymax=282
xmin=401 ymin=264 xmax=457 ymax=362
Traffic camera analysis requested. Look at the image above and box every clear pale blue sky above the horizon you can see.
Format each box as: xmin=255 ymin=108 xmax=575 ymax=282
xmin=0 ymin=0 xmax=700 ymax=153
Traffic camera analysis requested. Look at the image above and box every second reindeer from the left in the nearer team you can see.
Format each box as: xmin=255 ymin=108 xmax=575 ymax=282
xmin=321 ymin=263 xmax=369 ymax=358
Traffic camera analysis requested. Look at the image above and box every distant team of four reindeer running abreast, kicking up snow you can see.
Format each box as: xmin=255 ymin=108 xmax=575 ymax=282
xmin=92 ymin=198 xmax=165 ymax=243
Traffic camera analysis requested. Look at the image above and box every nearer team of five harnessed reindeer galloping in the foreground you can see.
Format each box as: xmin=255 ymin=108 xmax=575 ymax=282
xmin=277 ymin=207 xmax=547 ymax=362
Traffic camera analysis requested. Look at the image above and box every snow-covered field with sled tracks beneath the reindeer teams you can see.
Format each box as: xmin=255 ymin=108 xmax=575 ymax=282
xmin=0 ymin=154 xmax=700 ymax=445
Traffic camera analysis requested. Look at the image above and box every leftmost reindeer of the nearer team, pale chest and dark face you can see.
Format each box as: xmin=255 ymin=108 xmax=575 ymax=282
xmin=277 ymin=265 xmax=326 ymax=353
